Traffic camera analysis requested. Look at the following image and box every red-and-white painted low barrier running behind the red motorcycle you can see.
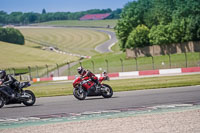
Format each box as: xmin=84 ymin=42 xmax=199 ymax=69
xmin=33 ymin=67 xmax=200 ymax=82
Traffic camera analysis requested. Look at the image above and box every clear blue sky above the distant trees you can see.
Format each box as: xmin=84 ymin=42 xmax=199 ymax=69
xmin=0 ymin=0 xmax=133 ymax=13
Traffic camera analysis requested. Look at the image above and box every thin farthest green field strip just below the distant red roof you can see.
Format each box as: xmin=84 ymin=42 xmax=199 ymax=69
xmin=34 ymin=19 xmax=117 ymax=28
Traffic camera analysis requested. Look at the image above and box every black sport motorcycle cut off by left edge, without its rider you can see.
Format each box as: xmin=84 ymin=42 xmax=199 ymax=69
xmin=0 ymin=81 xmax=36 ymax=108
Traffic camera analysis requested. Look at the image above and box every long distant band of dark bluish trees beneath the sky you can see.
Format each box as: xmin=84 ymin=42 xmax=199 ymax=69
xmin=0 ymin=8 xmax=122 ymax=24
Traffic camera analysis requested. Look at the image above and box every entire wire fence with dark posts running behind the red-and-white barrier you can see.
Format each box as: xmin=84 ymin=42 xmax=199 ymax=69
xmin=1 ymin=53 xmax=200 ymax=80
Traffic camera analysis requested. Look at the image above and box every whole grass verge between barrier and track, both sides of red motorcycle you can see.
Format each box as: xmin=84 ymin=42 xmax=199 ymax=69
xmin=29 ymin=74 xmax=200 ymax=97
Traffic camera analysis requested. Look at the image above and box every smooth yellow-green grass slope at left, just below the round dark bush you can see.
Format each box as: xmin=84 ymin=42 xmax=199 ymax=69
xmin=0 ymin=41 xmax=77 ymax=69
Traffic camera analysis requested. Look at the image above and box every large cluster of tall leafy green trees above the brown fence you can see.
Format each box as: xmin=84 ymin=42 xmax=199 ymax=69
xmin=115 ymin=0 xmax=200 ymax=50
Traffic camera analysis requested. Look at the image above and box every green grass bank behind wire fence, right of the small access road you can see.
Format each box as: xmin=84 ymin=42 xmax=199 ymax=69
xmin=64 ymin=53 xmax=200 ymax=75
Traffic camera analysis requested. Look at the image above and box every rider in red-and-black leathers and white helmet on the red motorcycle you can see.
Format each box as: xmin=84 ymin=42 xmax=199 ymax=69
xmin=77 ymin=67 xmax=100 ymax=91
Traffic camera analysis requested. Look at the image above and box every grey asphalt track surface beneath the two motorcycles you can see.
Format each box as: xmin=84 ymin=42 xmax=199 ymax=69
xmin=0 ymin=86 xmax=200 ymax=119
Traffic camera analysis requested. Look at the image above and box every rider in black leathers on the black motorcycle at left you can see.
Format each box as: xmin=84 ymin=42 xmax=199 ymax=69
xmin=0 ymin=70 xmax=20 ymax=98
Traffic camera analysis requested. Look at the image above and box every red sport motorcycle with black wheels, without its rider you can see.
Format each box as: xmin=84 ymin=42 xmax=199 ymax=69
xmin=73 ymin=72 xmax=113 ymax=100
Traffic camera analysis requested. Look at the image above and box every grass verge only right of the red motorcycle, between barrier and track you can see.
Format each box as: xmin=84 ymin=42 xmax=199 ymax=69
xmin=106 ymin=74 xmax=200 ymax=91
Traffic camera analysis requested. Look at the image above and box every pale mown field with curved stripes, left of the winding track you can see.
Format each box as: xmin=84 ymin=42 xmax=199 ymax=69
xmin=20 ymin=28 xmax=109 ymax=55
